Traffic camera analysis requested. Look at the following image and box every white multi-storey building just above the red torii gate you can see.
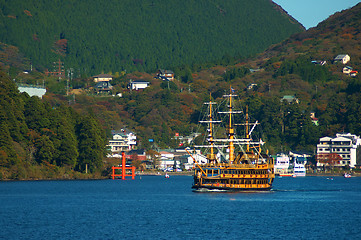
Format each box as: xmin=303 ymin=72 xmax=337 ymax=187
xmin=108 ymin=129 xmax=137 ymax=153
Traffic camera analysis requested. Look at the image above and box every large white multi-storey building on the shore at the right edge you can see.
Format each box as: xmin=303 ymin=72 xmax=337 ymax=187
xmin=316 ymin=133 xmax=361 ymax=168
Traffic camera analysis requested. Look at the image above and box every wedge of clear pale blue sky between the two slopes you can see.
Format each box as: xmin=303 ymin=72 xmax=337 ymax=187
xmin=273 ymin=0 xmax=361 ymax=29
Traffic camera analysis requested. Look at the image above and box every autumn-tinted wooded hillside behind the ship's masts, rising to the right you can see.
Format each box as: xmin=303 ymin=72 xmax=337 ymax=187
xmin=59 ymin=4 xmax=361 ymax=153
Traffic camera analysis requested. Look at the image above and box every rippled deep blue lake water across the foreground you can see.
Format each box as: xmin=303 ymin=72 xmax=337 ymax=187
xmin=0 ymin=176 xmax=361 ymax=239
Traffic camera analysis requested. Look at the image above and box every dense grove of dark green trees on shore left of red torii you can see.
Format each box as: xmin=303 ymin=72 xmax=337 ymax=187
xmin=0 ymin=71 xmax=107 ymax=180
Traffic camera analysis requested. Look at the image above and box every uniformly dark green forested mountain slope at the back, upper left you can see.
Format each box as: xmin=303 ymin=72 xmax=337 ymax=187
xmin=0 ymin=0 xmax=304 ymax=76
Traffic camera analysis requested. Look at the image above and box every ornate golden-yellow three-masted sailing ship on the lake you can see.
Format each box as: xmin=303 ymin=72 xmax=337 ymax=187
xmin=187 ymin=88 xmax=275 ymax=192
